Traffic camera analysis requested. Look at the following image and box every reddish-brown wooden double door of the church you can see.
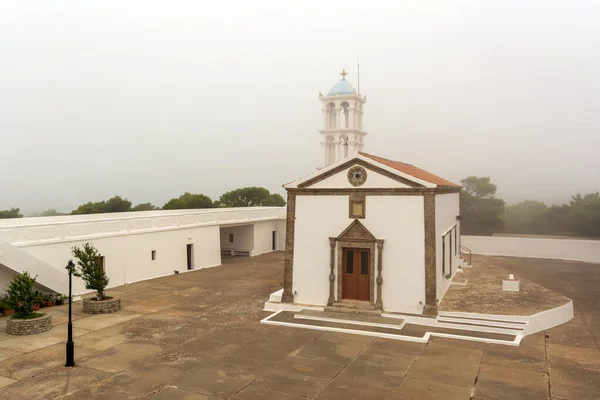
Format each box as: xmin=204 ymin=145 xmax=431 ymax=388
xmin=342 ymin=248 xmax=371 ymax=301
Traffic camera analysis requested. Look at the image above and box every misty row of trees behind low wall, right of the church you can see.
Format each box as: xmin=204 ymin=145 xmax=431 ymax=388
xmin=460 ymin=176 xmax=600 ymax=237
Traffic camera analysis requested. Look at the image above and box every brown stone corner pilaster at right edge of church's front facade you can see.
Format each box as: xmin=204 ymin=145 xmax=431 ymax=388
xmin=423 ymin=193 xmax=437 ymax=315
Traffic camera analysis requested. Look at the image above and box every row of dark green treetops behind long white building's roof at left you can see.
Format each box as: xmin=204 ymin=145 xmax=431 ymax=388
xmin=0 ymin=186 xmax=286 ymax=219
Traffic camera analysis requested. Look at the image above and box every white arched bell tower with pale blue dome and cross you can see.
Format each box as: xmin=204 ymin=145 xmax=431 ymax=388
xmin=319 ymin=69 xmax=367 ymax=167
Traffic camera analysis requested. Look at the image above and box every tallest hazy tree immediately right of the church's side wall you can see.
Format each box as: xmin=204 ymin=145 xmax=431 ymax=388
xmin=459 ymin=176 xmax=504 ymax=235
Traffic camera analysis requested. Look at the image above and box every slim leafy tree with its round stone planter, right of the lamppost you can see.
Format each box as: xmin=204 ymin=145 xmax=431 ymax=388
xmin=71 ymin=243 xmax=121 ymax=314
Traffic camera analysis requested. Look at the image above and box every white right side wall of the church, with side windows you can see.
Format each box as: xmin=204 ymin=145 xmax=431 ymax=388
xmin=435 ymin=193 xmax=462 ymax=301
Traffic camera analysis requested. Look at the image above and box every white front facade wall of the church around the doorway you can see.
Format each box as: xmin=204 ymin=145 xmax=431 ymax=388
xmin=293 ymin=195 xmax=425 ymax=313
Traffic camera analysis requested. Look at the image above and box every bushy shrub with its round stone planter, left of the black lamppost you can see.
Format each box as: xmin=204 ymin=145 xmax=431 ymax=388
xmin=6 ymin=272 xmax=52 ymax=335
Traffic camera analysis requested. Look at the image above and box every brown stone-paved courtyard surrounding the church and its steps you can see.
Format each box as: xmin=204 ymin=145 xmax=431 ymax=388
xmin=0 ymin=252 xmax=600 ymax=400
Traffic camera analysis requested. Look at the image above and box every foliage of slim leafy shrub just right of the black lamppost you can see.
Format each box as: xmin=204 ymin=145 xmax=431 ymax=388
xmin=71 ymin=243 xmax=109 ymax=300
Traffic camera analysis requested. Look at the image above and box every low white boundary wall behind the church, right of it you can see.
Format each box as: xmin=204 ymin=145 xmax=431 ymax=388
xmin=461 ymin=236 xmax=600 ymax=263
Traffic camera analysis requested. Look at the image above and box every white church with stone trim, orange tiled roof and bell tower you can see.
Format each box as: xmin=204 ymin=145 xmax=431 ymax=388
xmin=281 ymin=71 xmax=462 ymax=314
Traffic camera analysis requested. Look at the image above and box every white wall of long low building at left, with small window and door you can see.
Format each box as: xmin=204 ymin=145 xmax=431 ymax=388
xmin=18 ymin=226 xmax=221 ymax=294
